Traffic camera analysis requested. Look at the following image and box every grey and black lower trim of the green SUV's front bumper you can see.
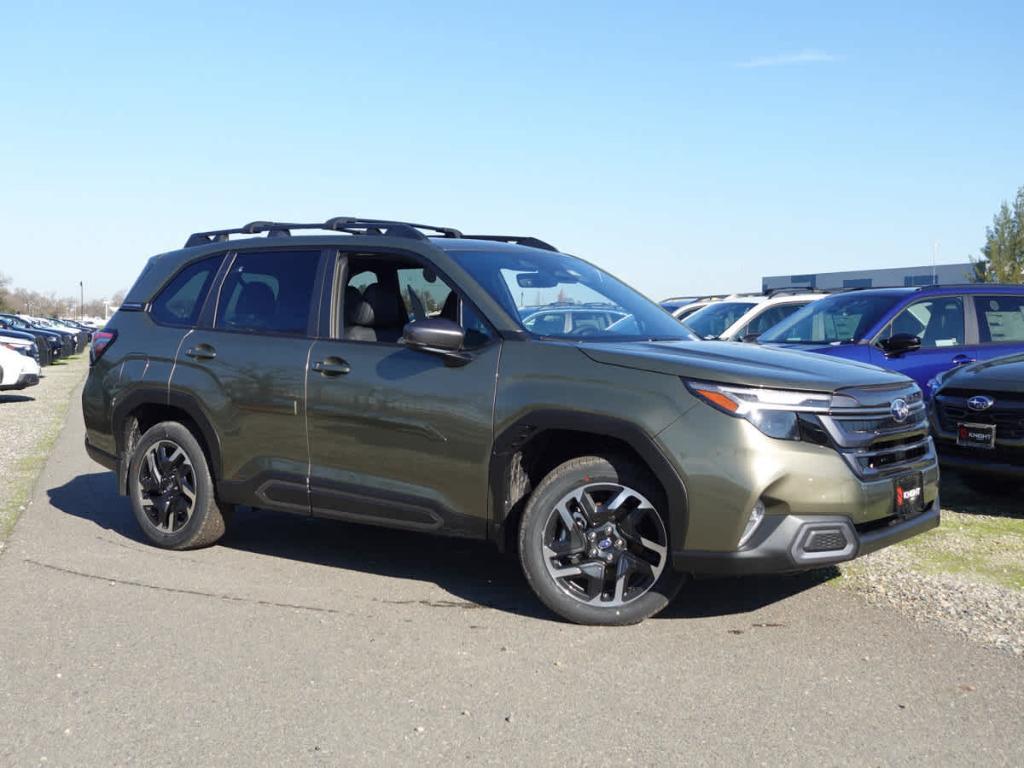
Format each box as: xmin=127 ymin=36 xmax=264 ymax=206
xmin=673 ymin=498 xmax=940 ymax=575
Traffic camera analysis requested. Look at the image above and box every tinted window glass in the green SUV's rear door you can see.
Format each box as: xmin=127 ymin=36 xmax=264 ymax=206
xmin=214 ymin=251 xmax=319 ymax=335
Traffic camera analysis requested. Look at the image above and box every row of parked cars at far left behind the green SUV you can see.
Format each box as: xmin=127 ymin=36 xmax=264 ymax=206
xmin=0 ymin=313 xmax=96 ymax=389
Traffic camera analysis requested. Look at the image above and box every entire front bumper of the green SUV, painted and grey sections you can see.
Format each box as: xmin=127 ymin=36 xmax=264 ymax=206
xmin=658 ymin=409 xmax=940 ymax=574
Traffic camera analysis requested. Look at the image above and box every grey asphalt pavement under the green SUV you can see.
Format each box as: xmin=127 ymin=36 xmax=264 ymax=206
xmin=0 ymin=387 xmax=1024 ymax=766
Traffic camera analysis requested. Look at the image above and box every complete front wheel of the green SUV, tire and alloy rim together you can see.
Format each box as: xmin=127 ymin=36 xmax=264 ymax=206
xmin=518 ymin=456 xmax=684 ymax=626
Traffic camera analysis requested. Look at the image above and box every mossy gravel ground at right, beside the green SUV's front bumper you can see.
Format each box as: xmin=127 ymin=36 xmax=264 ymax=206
xmin=839 ymin=473 xmax=1024 ymax=655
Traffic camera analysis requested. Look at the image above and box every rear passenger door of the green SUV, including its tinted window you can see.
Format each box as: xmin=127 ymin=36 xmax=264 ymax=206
xmin=171 ymin=248 xmax=323 ymax=514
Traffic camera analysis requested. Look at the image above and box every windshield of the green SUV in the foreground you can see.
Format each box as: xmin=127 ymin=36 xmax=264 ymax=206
xmin=449 ymin=250 xmax=693 ymax=341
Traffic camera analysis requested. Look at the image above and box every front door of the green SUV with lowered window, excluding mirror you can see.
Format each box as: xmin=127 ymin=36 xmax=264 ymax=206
xmin=307 ymin=254 xmax=500 ymax=538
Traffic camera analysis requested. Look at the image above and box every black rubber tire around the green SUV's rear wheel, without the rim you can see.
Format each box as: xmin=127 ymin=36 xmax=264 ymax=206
xmin=128 ymin=422 xmax=213 ymax=549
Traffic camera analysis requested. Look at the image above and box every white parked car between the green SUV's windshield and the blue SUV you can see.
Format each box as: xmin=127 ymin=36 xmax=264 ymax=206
xmin=683 ymin=293 xmax=825 ymax=341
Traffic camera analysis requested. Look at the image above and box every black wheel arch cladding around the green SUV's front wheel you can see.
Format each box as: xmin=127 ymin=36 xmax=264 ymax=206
xmin=488 ymin=410 xmax=689 ymax=551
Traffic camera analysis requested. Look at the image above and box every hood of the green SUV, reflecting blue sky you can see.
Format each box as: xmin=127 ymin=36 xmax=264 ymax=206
xmin=580 ymin=341 xmax=910 ymax=392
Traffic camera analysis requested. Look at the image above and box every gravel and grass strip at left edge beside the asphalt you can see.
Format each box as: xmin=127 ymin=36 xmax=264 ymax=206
xmin=0 ymin=354 xmax=88 ymax=549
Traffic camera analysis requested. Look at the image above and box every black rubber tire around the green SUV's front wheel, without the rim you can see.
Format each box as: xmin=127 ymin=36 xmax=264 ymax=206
xmin=519 ymin=457 xmax=684 ymax=625
